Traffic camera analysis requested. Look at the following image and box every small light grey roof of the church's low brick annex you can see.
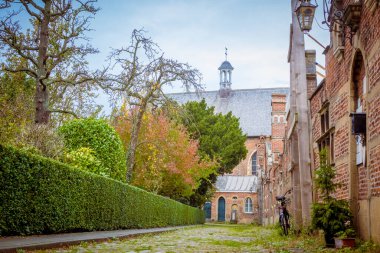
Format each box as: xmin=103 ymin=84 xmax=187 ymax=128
xmin=215 ymin=175 xmax=257 ymax=192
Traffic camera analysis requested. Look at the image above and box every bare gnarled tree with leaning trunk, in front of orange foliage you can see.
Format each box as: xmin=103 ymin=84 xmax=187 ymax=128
xmin=98 ymin=30 xmax=202 ymax=182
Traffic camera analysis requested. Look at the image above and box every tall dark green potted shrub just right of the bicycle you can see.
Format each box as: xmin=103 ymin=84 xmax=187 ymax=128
xmin=312 ymin=149 xmax=352 ymax=247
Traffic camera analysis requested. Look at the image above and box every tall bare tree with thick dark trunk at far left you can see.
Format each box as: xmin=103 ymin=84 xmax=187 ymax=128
xmin=0 ymin=0 xmax=98 ymax=124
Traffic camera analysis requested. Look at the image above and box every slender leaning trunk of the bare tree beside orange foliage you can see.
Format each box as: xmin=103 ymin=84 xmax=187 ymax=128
xmin=126 ymin=102 xmax=147 ymax=183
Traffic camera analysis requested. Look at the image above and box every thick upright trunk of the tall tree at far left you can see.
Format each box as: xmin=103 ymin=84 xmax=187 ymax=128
xmin=35 ymin=0 xmax=51 ymax=124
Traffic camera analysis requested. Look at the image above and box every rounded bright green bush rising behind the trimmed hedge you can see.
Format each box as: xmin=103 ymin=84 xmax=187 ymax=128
xmin=59 ymin=118 xmax=126 ymax=181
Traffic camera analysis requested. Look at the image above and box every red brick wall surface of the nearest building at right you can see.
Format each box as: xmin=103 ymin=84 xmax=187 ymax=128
xmin=310 ymin=0 xmax=380 ymax=242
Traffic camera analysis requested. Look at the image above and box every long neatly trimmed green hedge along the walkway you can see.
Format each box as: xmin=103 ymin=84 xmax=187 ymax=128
xmin=0 ymin=145 xmax=204 ymax=235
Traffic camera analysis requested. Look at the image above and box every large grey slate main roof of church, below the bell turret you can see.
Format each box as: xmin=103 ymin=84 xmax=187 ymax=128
xmin=168 ymin=88 xmax=289 ymax=136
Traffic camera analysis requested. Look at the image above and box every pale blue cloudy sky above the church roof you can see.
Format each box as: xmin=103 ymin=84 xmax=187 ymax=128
xmin=88 ymin=0 xmax=329 ymax=92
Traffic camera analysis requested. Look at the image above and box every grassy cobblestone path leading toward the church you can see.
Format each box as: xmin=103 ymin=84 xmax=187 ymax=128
xmin=32 ymin=224 xmax=378 ymax=253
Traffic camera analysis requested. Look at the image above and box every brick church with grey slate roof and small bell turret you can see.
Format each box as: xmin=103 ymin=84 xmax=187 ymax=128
xmin=169 ymin=53 xmax=289 ymax=223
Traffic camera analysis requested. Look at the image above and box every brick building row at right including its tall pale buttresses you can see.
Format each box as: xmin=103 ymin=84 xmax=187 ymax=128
xmin=262 ymin=0 xmax=380 ymax=243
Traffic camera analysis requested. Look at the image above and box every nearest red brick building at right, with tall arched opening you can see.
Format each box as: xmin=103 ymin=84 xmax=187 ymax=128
xmin=310 ymin=0 xmax=380 ymax=243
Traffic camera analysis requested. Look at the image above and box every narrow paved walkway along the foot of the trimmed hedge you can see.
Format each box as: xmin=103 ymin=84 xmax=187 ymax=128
xmin=0 ymin=226 xmax=190 ymax=252
